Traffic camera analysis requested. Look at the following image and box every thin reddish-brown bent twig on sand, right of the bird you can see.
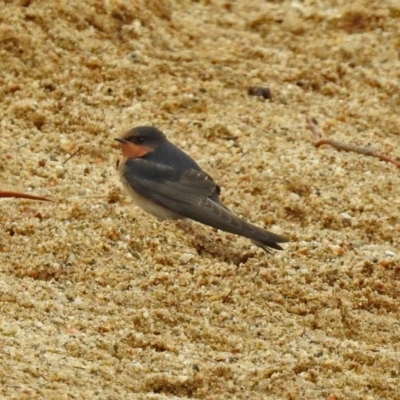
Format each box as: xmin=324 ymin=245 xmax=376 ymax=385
xmin=306 ymin=117 xmax=400 ymax=168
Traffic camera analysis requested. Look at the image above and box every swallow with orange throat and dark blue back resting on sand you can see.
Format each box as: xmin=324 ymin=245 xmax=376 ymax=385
xmin=115 ymin=126 xmax=287 ymax=252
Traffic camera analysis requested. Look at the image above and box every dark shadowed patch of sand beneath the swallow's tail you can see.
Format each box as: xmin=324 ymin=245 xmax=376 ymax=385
xmin=176 ymin=220 xmax=257 ymax=266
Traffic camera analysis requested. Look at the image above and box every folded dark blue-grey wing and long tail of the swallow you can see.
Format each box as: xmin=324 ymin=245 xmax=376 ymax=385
xmin=124 ymin=158 xmax=287 ymax=250
